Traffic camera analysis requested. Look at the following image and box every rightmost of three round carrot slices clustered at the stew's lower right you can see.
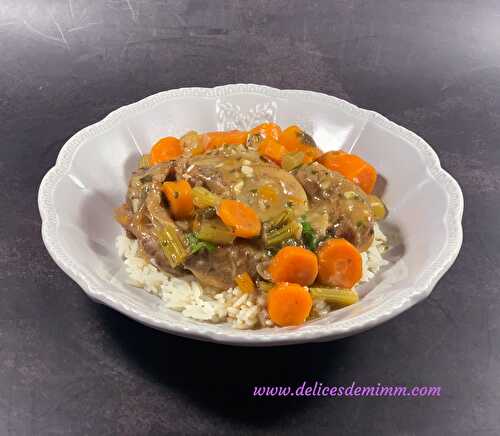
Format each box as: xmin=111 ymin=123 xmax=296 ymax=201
xmin=318 ymin=239 xmax=363 ymax=288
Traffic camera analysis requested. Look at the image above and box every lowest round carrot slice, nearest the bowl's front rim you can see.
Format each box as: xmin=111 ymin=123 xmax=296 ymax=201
xmin=267 ymin=283 xmax=312 ymax=326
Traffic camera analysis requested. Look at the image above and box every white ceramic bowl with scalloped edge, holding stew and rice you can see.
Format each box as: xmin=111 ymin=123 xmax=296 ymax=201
xmin=38 ymin=85 xmax=463 ymax=345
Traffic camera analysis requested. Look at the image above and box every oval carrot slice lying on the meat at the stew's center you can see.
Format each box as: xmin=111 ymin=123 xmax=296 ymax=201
xmin=217 ymin=200 xmax=261 ymax=238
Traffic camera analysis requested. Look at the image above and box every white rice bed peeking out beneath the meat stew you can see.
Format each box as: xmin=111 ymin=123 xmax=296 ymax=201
xmin=116 ymin=225 xmax=387 ymax=329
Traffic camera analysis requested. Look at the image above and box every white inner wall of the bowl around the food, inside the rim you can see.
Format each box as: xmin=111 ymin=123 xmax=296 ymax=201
xmin=49 ymin=93 xmax=449 ymax=334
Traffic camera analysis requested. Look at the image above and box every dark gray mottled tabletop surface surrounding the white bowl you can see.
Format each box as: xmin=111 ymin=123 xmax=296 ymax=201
xmin=0 ymin=0 xmax=500 ymax=436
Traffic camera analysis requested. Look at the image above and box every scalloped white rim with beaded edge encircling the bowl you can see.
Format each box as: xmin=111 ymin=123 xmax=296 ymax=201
xmin=38 ymin=84 xmax=464 ymax=346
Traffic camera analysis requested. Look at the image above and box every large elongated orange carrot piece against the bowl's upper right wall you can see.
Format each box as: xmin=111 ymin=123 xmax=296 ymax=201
xmin=319 ymin=151 xmax=377 ymax=194
